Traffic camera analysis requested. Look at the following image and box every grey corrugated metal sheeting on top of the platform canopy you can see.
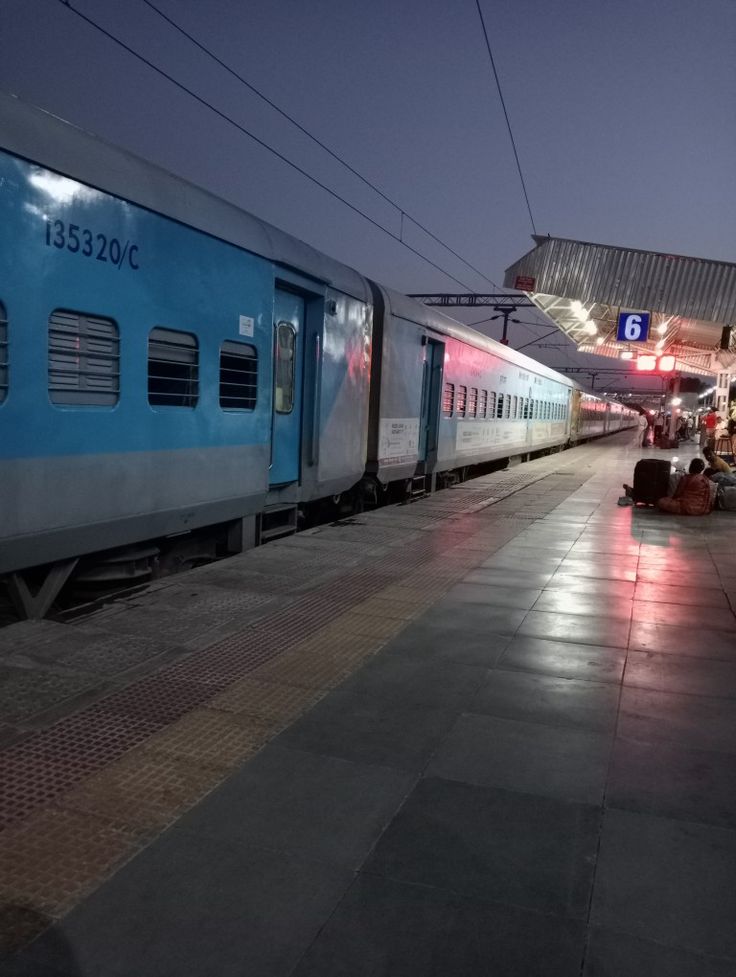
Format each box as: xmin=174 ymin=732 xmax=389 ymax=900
xmin=504 ymin=237 xmax=736 ymax=325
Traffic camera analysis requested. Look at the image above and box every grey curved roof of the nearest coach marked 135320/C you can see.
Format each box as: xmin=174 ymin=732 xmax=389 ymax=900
xmin=0 ymin=92 xmax=370 ymax=301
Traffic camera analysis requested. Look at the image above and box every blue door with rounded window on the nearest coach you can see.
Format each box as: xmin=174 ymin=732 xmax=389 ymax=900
xmin=269 ymin=288 xmax=304 ymax=488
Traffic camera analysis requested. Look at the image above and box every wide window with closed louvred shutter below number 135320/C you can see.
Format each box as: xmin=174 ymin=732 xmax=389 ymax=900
xmin=49 ymin=309 xmax=120 ymax=407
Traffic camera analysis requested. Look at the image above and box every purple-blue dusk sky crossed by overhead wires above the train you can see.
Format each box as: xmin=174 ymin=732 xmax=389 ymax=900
xmin=0 ymin=0 xmax=736 ymax=387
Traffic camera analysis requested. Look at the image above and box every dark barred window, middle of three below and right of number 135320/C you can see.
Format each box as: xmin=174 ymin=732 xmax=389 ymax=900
xmin=148 ymin=328 xmax=199 ymax=407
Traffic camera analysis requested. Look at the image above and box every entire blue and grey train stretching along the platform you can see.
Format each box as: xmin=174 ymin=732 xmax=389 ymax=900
xmin=0 ymin=95 xmax=636 ymax=617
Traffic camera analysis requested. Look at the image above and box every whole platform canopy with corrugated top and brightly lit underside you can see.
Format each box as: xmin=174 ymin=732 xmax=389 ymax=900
xmin=504 ymin=235 xmax=736 ymax=376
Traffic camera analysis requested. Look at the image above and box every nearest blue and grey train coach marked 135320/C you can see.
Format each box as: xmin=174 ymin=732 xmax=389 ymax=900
xmin=0 ymin=95 xmax=371 ymax=615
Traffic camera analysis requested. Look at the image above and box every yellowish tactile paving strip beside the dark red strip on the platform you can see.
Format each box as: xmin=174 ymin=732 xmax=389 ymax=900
xmin=0 ymin=464 xmax=588 ymax=950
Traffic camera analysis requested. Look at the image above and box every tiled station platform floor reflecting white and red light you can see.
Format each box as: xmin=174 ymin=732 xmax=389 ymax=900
xmin=0 ymin=433 xmax=736 ymax=977
